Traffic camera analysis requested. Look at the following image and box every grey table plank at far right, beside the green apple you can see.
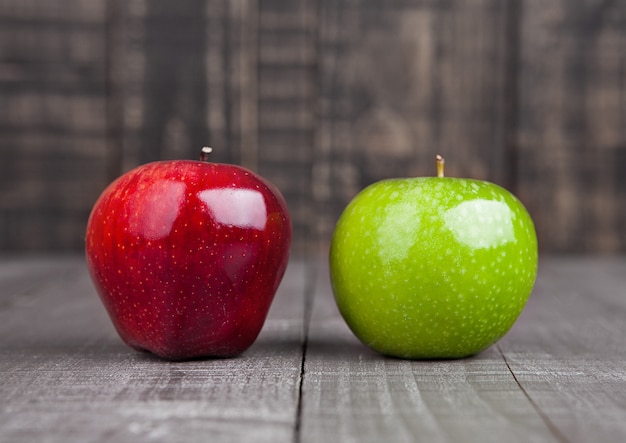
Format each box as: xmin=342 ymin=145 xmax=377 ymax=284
xmin=499 ymin=258 xmax=626 ymax=442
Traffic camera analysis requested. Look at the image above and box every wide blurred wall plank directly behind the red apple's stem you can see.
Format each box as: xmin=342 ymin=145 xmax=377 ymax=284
xmin=97 ymin=0 xmax=317 ymax=252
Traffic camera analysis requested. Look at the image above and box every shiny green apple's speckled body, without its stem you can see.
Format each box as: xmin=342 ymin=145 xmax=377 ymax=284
xmin=330 ymin=177 xmax=538 ymax=359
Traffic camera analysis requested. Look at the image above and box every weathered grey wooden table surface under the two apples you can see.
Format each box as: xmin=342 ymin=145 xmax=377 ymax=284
xmin=0 ymin=256 xmax=626 ymax=443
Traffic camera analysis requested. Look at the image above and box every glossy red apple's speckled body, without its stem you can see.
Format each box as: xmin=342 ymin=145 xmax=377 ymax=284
xmin=85 ymin=160 xmax=291 ymax=360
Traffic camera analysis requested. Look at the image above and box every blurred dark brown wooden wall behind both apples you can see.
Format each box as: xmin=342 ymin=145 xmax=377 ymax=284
xmin=0 ymin=0 xmax=626 ymax=253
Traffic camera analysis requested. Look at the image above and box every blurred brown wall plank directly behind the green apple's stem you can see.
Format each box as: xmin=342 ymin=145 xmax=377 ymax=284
xmin=313 ymin=0 xmax=510 ymax=253
